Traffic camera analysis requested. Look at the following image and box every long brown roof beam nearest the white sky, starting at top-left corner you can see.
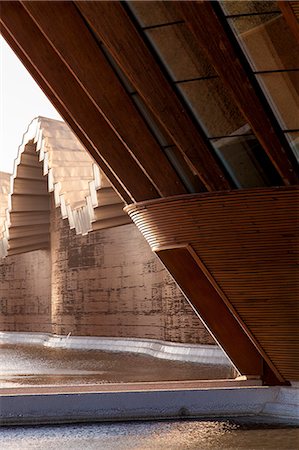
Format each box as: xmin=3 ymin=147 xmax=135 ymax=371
xmin=0 ymin=2 xmax=158 ymax=199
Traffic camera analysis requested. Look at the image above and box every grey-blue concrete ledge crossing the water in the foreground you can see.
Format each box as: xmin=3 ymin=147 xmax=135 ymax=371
xmin=1 ymin=387 xmax=299 ymax=425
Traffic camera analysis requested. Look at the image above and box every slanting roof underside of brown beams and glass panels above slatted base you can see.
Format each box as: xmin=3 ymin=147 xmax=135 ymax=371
xmin=1 ymin=1 xmax=299 ymax=382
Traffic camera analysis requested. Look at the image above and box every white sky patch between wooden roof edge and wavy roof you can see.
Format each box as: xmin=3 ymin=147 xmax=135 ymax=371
xmin=0 ymin=36 xmax=61 ymax=173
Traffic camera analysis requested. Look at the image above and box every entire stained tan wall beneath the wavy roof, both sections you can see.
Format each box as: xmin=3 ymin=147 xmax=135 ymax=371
xmin=0 ymin=202 xmax=214 ymax=344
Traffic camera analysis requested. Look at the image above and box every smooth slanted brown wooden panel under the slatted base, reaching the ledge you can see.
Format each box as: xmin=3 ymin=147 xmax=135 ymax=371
xmin=156 ymin=247 xmax=263 ymax=377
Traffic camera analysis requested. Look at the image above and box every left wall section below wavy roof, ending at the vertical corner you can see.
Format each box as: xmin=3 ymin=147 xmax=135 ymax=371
xmin=0 ymin=250 xmax=51 ymax=332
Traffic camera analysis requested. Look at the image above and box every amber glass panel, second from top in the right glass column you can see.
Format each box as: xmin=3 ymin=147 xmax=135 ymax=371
xmin=228 ymin=14 xmax=299 ymax=71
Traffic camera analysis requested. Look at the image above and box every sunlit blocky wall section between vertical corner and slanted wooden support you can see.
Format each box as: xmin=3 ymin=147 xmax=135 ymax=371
xmin=51 ymin=210 xmax=214 ymax=343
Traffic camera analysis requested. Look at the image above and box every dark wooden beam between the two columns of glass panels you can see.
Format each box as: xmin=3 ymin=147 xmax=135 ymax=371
xmin=175 ymin=1 xmax=299 ymax=185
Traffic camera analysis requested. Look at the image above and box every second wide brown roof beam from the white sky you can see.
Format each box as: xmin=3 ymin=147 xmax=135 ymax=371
xmin=22 ymin=2 xmax=186 ymax=196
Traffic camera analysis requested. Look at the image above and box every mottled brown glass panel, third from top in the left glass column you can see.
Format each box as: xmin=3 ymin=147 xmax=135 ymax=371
xmin=178 ymin=78 xmax=246 ymax=137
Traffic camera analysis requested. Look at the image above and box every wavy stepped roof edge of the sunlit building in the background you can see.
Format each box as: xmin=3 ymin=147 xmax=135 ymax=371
xmin=0 ymin=116 xmax=131 ymax=257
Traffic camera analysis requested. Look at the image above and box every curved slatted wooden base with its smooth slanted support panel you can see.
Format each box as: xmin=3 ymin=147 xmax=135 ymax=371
xmin=126 ymin=186 xmax=299 ymax=384
